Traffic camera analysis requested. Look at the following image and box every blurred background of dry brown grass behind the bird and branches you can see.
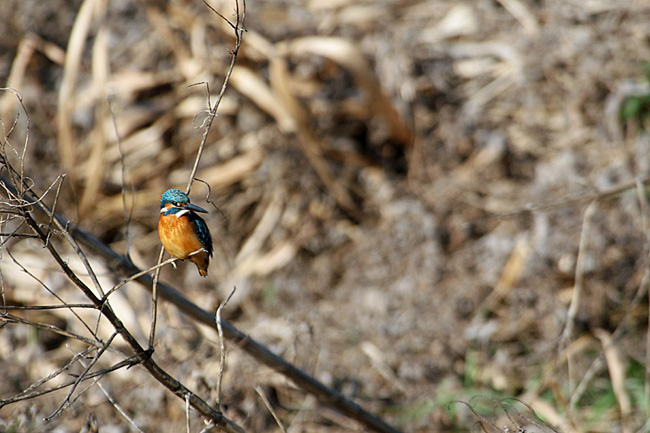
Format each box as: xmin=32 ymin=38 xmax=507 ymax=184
xmin=0 ymin=0 xmax=650 ymax=432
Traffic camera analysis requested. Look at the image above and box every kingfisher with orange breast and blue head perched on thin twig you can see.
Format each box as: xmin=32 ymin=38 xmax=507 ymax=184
xmin=158 ymin=189 xmax=212 ymax=277
